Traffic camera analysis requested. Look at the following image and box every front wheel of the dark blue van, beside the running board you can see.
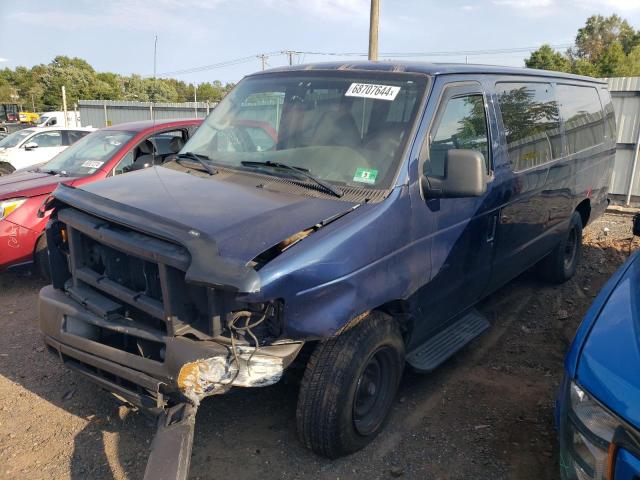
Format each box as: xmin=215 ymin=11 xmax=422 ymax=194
xmin=296 ymin=312 xmax=404 ymax=458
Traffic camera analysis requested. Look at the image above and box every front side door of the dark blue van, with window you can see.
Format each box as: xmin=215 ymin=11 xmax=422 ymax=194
xmin=416 ymin=82 xmax=497 ymax=342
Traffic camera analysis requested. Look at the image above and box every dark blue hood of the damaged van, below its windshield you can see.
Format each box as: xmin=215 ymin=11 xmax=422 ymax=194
xmin=77 ymin=167 xmax=355 ymax=264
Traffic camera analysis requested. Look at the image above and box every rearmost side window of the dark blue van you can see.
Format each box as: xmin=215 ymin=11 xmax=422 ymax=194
xmin=556 ymin=85 xmax=604 ymax=155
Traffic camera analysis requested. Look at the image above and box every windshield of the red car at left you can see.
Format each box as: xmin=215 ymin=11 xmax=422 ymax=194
xmin=40 ymin=130 xmax=136 ymax=176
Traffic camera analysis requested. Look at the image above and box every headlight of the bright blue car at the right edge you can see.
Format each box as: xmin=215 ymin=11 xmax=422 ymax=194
xmin=565 ymin=382 xmax=622 ymax=480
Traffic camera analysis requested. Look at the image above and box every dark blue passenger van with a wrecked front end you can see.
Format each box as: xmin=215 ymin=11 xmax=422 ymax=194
xmin=40 ymin=62 xmax=615 ymax=476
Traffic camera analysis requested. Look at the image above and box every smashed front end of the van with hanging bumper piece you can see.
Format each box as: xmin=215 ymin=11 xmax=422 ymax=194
xmin=39 ymin=181 xmax=370 ymax=479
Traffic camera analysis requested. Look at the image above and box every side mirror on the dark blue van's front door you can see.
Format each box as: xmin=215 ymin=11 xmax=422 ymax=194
xmin=420 ymin=149 xmax=489 ymax=198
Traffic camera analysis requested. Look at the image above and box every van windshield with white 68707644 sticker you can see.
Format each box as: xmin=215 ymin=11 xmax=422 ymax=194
xmin=182 ymin=71 xmax=427 ymax=189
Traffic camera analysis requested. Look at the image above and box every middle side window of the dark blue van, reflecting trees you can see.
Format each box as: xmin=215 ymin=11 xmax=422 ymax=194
xmin=496 ymin=82 xmax=562 ymax=171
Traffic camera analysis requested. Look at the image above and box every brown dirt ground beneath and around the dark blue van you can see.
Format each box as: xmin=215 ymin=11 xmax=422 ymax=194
xmin=0 ymin=214 xmax=637 ymax=480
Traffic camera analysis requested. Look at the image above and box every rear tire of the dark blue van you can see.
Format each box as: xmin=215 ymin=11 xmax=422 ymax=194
xmin=538 ymin=212 xmax=582 ymax=283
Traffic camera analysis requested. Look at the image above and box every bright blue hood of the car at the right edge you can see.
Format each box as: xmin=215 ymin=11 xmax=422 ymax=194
xmin=576 ymin=254 xmax=640 ymax=428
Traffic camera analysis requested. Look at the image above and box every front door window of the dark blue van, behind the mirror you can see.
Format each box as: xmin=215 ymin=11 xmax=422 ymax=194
xmin=424 ymin=94 xmax=489 ymax=177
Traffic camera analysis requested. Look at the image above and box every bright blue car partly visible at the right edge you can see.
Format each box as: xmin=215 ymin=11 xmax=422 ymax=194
xmin=556 ymin=244 xmax=640 ymax=480
